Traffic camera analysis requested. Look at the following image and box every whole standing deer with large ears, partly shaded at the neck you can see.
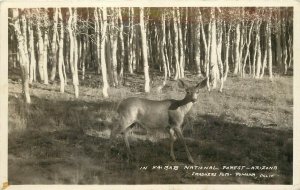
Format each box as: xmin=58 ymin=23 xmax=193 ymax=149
xmin=110 ymin=78 xmax=207 ymax=163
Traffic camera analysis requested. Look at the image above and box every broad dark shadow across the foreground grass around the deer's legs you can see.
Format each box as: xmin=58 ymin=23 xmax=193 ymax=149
xmin=8 ymin=95 xmax=293 ymax=184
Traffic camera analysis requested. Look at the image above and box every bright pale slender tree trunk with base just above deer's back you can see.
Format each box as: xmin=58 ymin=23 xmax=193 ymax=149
xmin=140 ymin=7 xmax=150 ymax=93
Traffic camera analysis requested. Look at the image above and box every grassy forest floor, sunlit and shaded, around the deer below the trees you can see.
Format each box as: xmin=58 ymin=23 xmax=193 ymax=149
xmin=8 ymin=68 xmax=293 ymax=184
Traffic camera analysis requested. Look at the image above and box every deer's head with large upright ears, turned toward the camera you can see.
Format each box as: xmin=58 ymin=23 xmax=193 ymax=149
xmin=178 ymin=78 xmax=207 ymax=102
